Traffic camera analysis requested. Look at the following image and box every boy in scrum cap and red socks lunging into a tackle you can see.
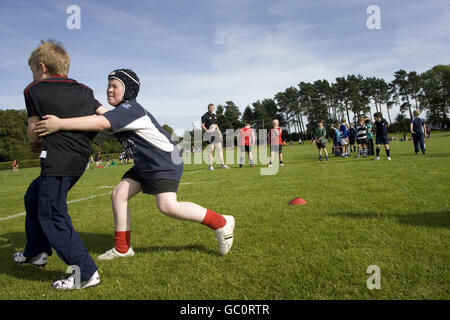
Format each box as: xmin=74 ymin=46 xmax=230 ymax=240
xmin=36 ymin=69 xmax=235 ymax=260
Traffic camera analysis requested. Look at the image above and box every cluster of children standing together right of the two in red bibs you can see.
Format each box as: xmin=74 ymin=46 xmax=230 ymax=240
xmin=314 ymin=112 xmax=391 ymax=161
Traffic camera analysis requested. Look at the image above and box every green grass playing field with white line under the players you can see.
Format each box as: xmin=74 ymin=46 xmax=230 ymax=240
xmin=0 ymin=132 xmax=450 ymax=300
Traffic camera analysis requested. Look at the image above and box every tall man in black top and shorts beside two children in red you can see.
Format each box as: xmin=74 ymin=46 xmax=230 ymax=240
xmin=202 ymin=103 xmax=230 ymax=170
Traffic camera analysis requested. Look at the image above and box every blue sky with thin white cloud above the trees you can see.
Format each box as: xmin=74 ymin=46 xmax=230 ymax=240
xmin=0 ymin=0 xmax=450 ymax=129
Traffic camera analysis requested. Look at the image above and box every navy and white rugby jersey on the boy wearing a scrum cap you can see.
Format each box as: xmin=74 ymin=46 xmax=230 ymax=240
xmin=103 ymin=99 xmax=183 ymax=180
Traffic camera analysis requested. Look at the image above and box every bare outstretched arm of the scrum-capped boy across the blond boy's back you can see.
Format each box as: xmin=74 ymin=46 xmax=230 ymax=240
xmin=34 ymin=115 xmax=111 ymax=137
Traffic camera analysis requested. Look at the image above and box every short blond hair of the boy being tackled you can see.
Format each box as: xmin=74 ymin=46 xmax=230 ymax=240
xmin=28 ymin=39 xmax=70 ymax=76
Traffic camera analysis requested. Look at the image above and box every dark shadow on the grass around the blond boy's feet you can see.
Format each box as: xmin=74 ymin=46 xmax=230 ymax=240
xmin=0 ymin=232 xmax=114 ymax=281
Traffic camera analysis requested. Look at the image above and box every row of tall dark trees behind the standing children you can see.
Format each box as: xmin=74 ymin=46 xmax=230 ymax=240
xmin=203 ymin=65 xmax=450 ymax=138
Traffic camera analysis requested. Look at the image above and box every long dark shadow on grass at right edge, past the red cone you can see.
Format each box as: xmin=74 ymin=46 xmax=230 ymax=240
xmin=331 ymin=211 xmax=450 ymax=229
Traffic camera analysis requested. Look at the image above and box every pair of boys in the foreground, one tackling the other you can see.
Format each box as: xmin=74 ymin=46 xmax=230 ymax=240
xmin=13 ymin=40 xmax=235 ymax=289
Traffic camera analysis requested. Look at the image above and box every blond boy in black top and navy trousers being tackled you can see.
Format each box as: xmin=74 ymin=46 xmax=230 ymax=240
xmin=14 ymin=41 xmax=106 ymax=289
